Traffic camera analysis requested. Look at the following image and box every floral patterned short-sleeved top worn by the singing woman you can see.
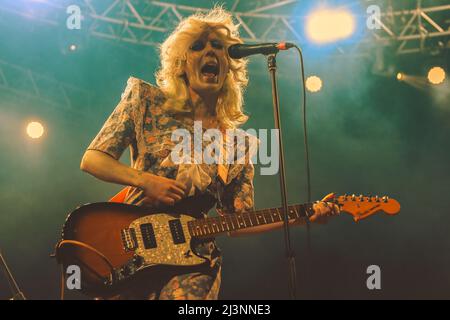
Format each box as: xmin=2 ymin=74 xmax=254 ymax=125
xmin=88 ymin=77 xmax=255 ymax=213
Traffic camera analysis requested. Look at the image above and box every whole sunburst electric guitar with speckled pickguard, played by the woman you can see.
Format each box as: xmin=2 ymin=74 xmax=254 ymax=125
xmin=55 ymin=195 xmax=400 ymax=297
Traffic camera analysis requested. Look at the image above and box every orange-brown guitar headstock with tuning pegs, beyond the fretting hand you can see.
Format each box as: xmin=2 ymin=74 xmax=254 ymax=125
xmin=334 ymin=195 xmax=400 ymax=222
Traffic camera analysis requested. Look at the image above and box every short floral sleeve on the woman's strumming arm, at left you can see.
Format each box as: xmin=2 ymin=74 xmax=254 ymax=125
xmin=88 ymin=78 xmax=140 ymax=159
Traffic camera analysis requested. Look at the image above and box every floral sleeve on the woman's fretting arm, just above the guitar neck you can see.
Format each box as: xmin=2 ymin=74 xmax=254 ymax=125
xmin=217 ymin=163 xmax=255 ymax=213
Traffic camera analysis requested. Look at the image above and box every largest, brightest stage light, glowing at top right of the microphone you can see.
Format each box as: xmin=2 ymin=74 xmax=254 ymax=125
xmin=305 ymin=9 xmax=356 ymax=43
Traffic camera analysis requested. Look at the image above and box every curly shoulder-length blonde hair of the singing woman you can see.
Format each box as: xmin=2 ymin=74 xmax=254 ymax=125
xmin=156 ymin=6 xmax=248 ymax=128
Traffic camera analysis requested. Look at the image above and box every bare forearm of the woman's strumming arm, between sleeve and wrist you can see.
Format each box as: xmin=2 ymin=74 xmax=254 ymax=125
xmin=80 ymin=150 xmax=143 ymax=187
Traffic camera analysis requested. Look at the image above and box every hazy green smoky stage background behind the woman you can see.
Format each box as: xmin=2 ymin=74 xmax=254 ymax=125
xmin=0 ymin=0 xmax=450 ymax=299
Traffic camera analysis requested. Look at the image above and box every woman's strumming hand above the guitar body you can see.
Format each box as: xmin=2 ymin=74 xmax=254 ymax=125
xmin=139 ymin=172 xmax=186 ymax=206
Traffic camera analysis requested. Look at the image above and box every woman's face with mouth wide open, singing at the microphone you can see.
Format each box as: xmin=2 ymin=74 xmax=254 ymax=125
xmin=185 ymin=32 xmax=229 ymax=94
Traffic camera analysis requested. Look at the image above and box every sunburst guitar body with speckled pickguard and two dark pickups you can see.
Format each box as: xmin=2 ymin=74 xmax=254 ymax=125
xmin=56 ymin=198 xmax=215 ymax=297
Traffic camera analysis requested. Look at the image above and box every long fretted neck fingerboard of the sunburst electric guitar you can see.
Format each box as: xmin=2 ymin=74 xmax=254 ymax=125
xmin=188 ymin=204 xmax=306 ymax=237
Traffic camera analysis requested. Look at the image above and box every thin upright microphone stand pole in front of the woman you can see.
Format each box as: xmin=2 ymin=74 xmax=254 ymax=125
xmin=267 ymin=54 xmax=297 ymax=300
